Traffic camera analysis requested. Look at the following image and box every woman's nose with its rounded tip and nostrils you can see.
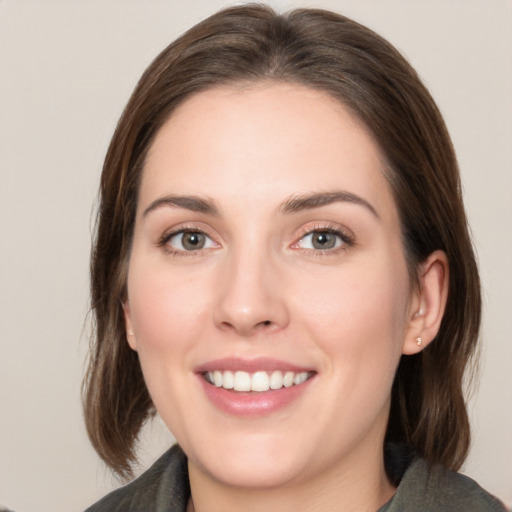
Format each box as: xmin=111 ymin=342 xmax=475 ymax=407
xmin=214 ymin=247 xmax=289 ymax=337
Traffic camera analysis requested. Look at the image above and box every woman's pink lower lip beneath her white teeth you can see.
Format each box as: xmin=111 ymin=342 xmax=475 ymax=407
xmin=199 ymin=375 xmax=314 ymax=417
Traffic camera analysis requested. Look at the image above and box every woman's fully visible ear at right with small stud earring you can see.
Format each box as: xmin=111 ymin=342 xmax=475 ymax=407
xmin=402 ymin=251 xmax=449 ymax=355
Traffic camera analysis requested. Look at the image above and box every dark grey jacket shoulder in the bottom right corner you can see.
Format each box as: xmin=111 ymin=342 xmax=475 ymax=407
xmin=382 ymin=459 xmax=505 ymax=512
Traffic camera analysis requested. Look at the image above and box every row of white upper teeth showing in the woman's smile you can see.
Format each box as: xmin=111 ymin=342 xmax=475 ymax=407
xmin=205 ymin=370 xmax=310 ymax=392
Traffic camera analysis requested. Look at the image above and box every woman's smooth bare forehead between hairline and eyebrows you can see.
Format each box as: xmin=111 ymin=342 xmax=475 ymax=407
xmin=141 ymin=83 xmax=393 ymax=220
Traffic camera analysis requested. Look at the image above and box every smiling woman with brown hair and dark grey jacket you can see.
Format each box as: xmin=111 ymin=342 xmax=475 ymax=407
xmin=85 ymin=5 xmax=503 ymax=512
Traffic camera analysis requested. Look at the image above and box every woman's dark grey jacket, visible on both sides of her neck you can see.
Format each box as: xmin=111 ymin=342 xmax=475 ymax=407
xmin=86 ymin=445 xmax=505 ymax=512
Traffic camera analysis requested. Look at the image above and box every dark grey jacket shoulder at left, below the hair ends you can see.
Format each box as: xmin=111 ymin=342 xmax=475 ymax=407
xmin=85 ymin=445 xmax=190 ymax=512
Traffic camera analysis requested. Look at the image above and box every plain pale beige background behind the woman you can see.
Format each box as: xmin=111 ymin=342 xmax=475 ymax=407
xmin=0 ymin=0 xmax=512 ymax=512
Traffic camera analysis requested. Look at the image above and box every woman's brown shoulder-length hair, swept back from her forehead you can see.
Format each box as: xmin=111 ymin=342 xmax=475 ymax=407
xmin=84 ymin=4 xmax=481 ymax=476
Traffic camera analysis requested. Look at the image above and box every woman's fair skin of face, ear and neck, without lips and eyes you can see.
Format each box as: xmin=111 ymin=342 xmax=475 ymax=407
xmin=124 ymin=84 xmax=447 ymax=512
